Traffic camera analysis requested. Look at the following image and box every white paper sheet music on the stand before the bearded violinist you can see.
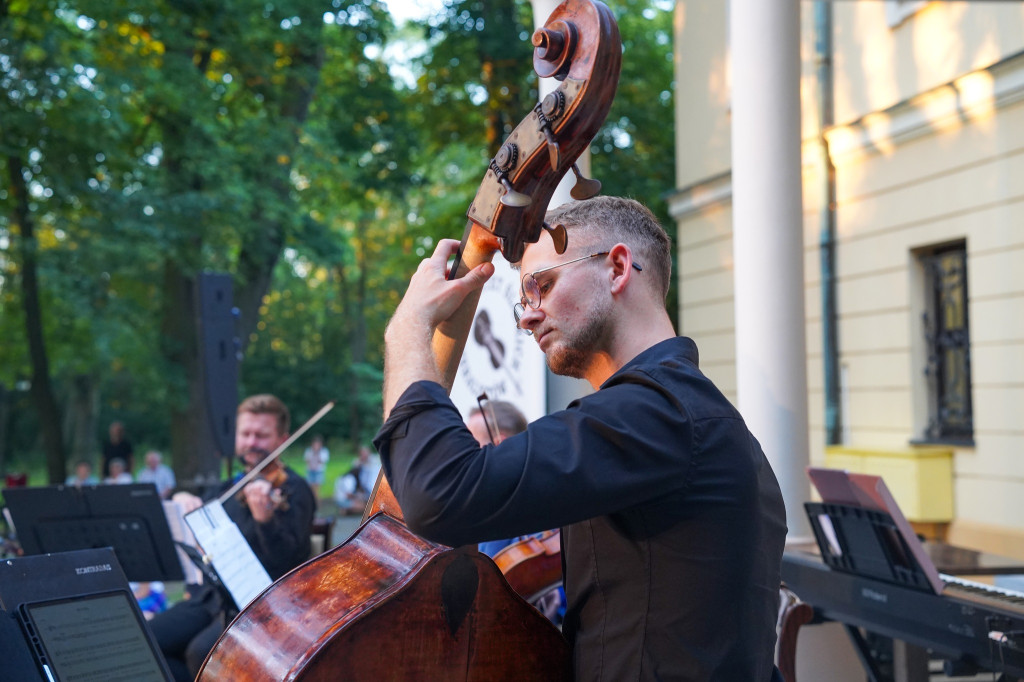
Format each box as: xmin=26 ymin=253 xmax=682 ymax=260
xmin=185 ymin=500 xmax=273 ymax=609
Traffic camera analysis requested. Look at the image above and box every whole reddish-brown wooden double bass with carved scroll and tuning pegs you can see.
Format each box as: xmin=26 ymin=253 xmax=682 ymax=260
xmin=199 ymin=0 xmax=622 ymax=682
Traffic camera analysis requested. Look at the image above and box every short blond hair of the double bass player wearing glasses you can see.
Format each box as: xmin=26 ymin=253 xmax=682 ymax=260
xmin=545 ymin=192 xmax=672 ymax=298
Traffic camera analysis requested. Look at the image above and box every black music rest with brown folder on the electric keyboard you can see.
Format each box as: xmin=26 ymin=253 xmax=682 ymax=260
xmin=804 ymin=467 xmax=943 ymax=594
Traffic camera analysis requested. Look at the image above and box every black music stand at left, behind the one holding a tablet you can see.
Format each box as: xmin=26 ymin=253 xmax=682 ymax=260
xmin=3 ymin=483 xmax=184 ymax=582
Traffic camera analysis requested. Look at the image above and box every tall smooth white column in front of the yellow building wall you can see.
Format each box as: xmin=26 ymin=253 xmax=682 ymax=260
xmin=729 ymin=0 xmax=810 ymax=541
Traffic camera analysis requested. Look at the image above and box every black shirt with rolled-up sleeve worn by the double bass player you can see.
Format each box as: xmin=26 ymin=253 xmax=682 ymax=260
xmin=375 ymin=337 xmax=786 ymax=682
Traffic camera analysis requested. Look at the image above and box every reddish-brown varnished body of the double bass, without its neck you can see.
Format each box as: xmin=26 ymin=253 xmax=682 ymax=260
xmin=200 ymin=514 xmax=571 ymax=682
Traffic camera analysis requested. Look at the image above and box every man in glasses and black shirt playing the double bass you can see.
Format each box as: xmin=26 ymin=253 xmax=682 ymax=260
xmin=375 ymin=197 xmax=786 ymax=682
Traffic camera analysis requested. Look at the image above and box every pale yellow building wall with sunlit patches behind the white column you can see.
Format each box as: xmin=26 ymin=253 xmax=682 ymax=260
xmin=670 ymin=0 xmax=1024 ymax=557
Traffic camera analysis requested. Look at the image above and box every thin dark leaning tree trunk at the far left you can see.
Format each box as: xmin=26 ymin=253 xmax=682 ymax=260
xmin=7 ymin=156 xmax=67 ymax=483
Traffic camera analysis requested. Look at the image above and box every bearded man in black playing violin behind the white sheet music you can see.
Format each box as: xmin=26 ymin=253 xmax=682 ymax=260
xmin=150 ymin=394 xmax=316 ymax=681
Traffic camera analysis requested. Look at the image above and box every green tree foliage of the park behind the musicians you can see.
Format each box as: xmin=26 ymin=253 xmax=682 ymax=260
xmin=0 ymin=0 xmax=673 ymax=481
